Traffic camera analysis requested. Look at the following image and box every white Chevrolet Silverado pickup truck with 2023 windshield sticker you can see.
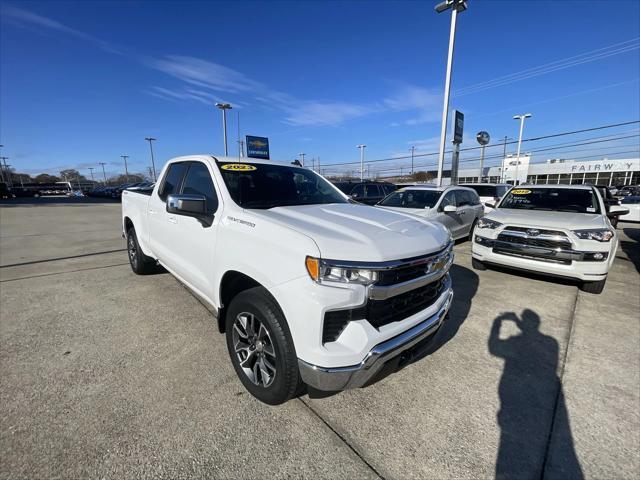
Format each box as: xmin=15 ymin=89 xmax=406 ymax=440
xmin=122 ymin=155 xmax=453 ymax=404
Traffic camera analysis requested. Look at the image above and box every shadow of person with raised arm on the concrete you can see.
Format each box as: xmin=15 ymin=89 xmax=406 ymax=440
xmin=488 ymin=309 xmax=584 ymax=480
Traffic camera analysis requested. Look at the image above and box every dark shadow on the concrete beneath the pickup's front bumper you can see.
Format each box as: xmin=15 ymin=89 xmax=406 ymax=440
xmin=303 ymin=264 xmax=479 ymax=399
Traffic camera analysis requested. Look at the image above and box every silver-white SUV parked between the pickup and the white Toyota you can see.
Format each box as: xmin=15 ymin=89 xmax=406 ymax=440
xmin=378 ymin=185 xmax=484 ymax=240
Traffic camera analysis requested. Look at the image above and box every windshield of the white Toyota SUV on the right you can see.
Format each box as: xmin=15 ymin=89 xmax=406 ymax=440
xmin=500 ymin=187 xmax=600 ymax=213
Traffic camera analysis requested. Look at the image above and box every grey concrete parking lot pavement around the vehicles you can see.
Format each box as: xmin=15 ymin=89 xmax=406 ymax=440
xmin=0 ymin=200 xmax=640 ymax=479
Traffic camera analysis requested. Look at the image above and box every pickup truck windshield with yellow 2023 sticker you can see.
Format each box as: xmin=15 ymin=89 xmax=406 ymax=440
xmin=218 ymin=162 xmax=347 ymax=209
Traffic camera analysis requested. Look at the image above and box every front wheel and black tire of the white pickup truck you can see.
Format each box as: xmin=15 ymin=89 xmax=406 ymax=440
xmin=225 ymin=287 xmax=303 ymax=405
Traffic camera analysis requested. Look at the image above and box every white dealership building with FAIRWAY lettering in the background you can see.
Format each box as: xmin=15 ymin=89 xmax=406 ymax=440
xmin=458 ymin=156 xmax=640 ymax=186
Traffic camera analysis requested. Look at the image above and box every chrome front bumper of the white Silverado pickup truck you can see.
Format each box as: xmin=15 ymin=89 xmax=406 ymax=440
xmin=298 ymin=280 xmax=453 ymax=391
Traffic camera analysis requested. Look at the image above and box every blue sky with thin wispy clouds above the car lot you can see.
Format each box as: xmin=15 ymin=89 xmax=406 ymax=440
xmin=0 ymin=0 xmax=640 ymax=178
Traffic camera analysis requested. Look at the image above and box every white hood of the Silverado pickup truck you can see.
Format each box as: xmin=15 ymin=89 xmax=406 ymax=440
xmin=246 ymin=203 xmax=450 ymax=262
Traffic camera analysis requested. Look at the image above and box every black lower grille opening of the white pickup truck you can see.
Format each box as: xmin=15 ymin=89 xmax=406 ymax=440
xmin=322 ymin=278 xmax=445 ymax=343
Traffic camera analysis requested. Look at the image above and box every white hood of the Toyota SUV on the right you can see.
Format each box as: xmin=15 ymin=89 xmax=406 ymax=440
xmin=485 ymin=208 xmax=607 ymax=230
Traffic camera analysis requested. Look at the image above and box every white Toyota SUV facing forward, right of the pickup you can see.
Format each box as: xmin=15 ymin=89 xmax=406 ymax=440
xmin=471 ymin=185 xmax=628 ymax=293
